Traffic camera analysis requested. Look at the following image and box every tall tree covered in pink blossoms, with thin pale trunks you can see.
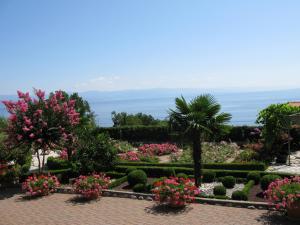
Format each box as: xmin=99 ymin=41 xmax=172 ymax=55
xmin=3 ymin=90 xmax=80 ymax=172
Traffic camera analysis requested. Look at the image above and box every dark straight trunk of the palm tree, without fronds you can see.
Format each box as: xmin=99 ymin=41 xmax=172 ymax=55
xmin=193 ymin=132 xmax=202 ymax=187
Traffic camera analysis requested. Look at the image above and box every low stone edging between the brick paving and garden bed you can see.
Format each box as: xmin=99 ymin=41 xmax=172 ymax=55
xmin=56 ymin=187 xmax=275 ymax=210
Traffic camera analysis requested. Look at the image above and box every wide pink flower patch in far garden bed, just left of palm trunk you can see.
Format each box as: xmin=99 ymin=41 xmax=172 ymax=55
xmin=138 ymin=143 xmax=178 ymax=156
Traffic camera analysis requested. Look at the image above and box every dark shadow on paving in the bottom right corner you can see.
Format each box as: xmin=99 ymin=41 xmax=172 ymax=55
xmin=257 ymin=212 xmax=300 ymax=225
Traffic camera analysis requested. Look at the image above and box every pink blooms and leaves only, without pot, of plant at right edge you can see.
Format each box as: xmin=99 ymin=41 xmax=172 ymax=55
xmin=265 ymin=176 xmax=300 ymax=209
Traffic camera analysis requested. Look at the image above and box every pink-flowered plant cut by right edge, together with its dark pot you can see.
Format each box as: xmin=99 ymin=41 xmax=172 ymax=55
xmin=265 ymin=176 xmax=300 ymax=220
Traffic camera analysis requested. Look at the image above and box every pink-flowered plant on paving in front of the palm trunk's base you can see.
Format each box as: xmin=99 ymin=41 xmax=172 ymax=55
xmin=152 ymin=177 xmax=200 ymax=207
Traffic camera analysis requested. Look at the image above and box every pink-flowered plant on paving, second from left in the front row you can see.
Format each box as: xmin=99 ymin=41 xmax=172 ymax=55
xmin=74 ymin=173 xmax=110 ymax=199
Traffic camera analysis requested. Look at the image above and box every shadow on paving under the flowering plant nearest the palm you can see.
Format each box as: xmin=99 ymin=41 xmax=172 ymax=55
xmin=144 ymin=204 xmax=192 ymax=215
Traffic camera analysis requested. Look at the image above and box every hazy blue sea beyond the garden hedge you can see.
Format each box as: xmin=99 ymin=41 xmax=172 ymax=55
xmin=0 ymin=89 xmax=300 ymax=127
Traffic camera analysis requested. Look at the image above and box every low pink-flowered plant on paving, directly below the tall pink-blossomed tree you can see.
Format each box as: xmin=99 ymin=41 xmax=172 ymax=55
xmin=22 ymin=175 xmax=60 ymax=196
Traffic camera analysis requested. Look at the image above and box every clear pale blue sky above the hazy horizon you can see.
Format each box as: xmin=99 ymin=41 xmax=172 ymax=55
xmin=0 ymin=0 xmax=300 ymax=94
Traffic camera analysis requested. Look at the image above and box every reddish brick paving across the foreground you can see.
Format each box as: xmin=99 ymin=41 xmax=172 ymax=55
xmin=0 ymin=194 xmax=296 ymax=225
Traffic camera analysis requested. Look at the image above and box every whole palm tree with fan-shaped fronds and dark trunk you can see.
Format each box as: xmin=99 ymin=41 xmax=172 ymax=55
xmin=169 ymin=94 xmax=231 ymax=187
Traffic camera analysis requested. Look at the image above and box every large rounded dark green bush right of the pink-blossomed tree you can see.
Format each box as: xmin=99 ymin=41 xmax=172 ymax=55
xmin=76 ymin=132 xmax=117 ymax=173
